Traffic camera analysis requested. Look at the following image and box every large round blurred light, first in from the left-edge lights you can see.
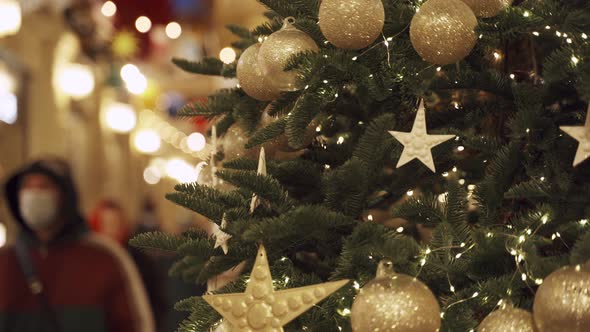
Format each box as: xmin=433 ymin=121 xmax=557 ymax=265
xmin=57 ymin=63 xmax=94 ymax=99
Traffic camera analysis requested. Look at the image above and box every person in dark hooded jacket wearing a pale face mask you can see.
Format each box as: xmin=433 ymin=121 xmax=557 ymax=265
xmin=0 ymin=159 xmax=154 ymax=332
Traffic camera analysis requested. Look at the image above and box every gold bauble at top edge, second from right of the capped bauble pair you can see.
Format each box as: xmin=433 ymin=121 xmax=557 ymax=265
xmin=319 ymin=0 xmax=385 ymax=50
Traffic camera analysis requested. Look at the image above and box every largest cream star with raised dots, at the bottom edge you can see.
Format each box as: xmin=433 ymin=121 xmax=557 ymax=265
xmin=203 ymin=245 xmax=348 ymax=332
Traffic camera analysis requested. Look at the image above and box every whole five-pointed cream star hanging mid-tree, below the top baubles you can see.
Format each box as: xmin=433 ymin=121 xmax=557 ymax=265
xmin=389 ymin=100 xmax=455 ymax=172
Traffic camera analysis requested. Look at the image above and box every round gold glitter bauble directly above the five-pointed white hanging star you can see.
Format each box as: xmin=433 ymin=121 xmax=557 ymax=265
xmin=410 ymin=0 xmax=477 ymax=65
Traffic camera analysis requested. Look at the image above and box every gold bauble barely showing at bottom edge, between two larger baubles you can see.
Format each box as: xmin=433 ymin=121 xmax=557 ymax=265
xmin=477 ymin=306 xmax=535 ymax=332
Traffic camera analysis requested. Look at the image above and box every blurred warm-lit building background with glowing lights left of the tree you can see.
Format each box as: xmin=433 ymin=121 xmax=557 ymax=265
xmin=0 ymin=0 xmax=264 ymax=245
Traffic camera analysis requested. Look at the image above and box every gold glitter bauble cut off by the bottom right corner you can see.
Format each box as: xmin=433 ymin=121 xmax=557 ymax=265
xmin=533 ymin=262 xmax=590 ymax=332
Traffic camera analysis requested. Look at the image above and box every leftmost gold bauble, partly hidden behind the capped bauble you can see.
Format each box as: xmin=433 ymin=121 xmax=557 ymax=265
xmin=237 ymin=44 xmax=280 ymax=101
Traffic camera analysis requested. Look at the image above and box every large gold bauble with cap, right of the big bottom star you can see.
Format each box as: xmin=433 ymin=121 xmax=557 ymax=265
xmin=350 ymin=260 xmax=441 ymax=332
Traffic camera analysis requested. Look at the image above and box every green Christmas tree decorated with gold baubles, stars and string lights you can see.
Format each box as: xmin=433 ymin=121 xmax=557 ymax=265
xmin=132 ymin=0 xmax=590 ymax=331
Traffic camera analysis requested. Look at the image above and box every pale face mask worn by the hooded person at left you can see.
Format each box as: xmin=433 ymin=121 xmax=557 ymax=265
xmin=19 ymin=189 xmax=57 ymax=230
